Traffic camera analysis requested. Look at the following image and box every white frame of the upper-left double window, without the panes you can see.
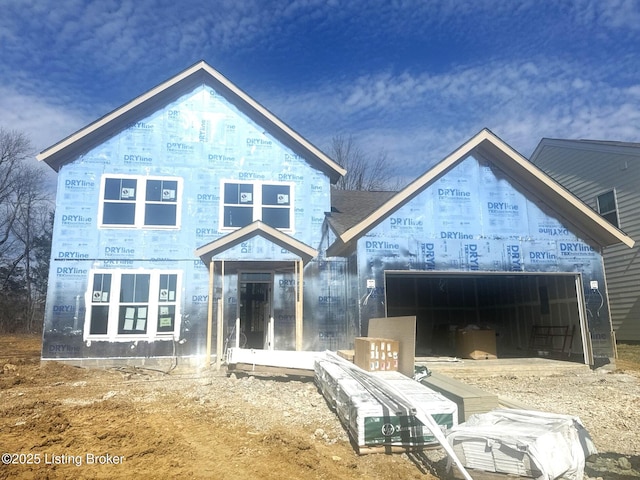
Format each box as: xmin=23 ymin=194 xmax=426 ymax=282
xmin=98 ymin=174 xmax=183 ymax=230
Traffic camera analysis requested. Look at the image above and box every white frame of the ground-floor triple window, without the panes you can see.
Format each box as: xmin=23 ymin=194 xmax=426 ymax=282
xmin=83 ymin=269 xmax=182 ymax=342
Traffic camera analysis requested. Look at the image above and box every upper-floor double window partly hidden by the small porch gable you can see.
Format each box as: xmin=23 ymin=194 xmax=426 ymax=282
xmin=221 ymin=182 xmax=293 ymax=230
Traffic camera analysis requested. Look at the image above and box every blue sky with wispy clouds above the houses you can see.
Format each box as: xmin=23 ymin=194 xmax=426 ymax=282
xmin=0 ymin=0 xmax=640 ymax=184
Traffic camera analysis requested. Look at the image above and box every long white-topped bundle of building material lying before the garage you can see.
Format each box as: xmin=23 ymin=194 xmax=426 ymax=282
xmin=315 ymin=358 xmax=458 ymax=454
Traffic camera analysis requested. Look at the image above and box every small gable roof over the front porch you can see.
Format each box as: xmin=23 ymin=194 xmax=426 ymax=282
xmin=195 ymin=220 xmax=318 ymax=265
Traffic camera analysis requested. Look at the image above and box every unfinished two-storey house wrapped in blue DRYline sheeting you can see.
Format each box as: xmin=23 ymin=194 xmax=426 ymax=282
xmin=38 ymin=62 xmax=633 ymax=365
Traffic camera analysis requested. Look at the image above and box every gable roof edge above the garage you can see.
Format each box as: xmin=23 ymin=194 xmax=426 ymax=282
xmin=327 ymin=129 xmax=635 ymax=255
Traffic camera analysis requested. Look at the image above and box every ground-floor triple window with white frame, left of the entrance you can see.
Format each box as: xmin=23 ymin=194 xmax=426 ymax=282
xmin=85 ymin=270 xmax=180 ymax=341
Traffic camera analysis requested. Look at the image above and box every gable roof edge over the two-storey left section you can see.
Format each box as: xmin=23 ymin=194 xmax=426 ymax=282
xmin=36 ymin=61 xmax=346 ymax=183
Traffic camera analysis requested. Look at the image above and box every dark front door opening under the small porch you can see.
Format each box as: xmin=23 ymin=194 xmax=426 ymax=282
xmin=238 ymin=272 xmax=273 ymax=349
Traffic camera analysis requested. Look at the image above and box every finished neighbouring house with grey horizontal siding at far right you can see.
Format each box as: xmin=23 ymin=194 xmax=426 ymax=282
xmin=531 ymin=138 xmax=640 ymax=342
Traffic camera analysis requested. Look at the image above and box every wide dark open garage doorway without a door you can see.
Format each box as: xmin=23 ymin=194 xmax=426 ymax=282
xmin=385 ymin=271 xmax=591 ymax=363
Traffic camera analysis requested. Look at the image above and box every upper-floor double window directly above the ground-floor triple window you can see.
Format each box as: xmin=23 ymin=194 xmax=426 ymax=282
xmin=100 ymin=175 xmax=182 ymax=228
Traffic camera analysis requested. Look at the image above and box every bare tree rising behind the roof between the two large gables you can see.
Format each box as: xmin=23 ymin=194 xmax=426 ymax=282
xmin=329 ymin=135 xmax=399 ymax=191
